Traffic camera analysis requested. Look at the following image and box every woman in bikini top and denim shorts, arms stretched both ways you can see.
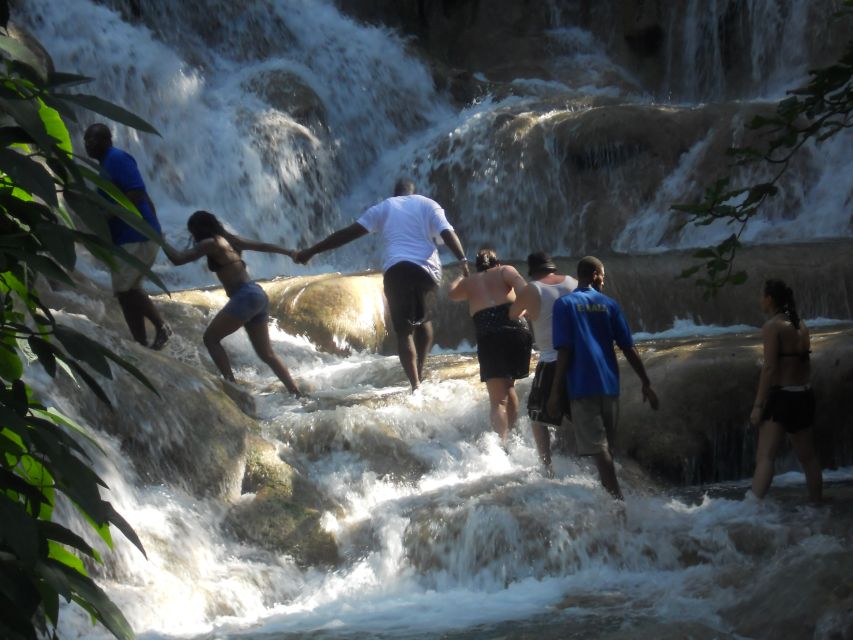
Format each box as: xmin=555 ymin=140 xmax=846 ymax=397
xmin=163 ymin=211 xmax=302 ymax=396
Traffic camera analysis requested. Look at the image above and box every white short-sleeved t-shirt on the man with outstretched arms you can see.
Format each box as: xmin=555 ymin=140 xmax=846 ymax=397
xmin=356 ymin=194 xmax=453 ymax=282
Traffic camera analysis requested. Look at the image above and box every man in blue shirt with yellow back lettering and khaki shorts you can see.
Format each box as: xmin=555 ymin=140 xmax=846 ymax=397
xmin=547 ymin=256 xmax=658 ymax=500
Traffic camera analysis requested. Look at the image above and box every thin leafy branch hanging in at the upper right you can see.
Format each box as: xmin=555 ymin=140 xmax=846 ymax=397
xmin=672 ymin=0 xmax=853 ymax=299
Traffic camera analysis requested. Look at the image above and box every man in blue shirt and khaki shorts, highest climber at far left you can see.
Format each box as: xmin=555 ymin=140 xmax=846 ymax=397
xmin=83 ymin=123 xmax=172 ymax=350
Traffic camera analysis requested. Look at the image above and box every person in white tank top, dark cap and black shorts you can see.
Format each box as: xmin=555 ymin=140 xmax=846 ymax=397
xmin=509 ymin=251 xmax=578 ymax=477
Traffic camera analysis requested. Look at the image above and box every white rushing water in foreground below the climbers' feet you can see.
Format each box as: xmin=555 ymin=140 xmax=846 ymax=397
xmin=25 ymin=318 xmax=853 ymax=639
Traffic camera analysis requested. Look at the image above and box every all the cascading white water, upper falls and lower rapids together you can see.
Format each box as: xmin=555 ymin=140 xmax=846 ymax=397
xmin=15 ymin=0 xmax=853 ymax=639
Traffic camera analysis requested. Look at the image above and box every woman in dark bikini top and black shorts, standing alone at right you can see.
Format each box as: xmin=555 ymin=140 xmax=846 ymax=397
xmin=749 ymin=280 xmax=823 ymax=502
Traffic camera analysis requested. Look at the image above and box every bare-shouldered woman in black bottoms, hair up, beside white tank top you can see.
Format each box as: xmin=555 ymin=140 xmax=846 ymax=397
xmin=448 ymin=249 xmax=533 ymax=445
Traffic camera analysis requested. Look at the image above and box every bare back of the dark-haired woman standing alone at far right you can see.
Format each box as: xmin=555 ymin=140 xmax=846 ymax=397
xmin=761 ymin=314 xmax=811 ymax=387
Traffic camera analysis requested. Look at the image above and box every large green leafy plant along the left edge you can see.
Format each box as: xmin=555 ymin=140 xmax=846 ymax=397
xmin=0 ymin=6 xmax=162 ymax=639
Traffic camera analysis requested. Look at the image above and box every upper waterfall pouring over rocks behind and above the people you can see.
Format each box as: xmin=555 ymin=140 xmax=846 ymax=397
xmin=16 ymin=0 xmax=853 ymax=268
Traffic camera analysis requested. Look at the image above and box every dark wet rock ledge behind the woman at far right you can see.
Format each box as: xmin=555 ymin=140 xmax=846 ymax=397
xmin=617 ymin=326 xmax=853 ymax=484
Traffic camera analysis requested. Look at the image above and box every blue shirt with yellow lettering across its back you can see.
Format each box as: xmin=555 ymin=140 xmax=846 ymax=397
xmin=552 ymin=287 xmax=634 ymax=398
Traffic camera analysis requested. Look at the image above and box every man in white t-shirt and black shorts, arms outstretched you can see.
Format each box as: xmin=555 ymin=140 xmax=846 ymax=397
xmin=294 ymin=178 xmax=468 ymax=391
